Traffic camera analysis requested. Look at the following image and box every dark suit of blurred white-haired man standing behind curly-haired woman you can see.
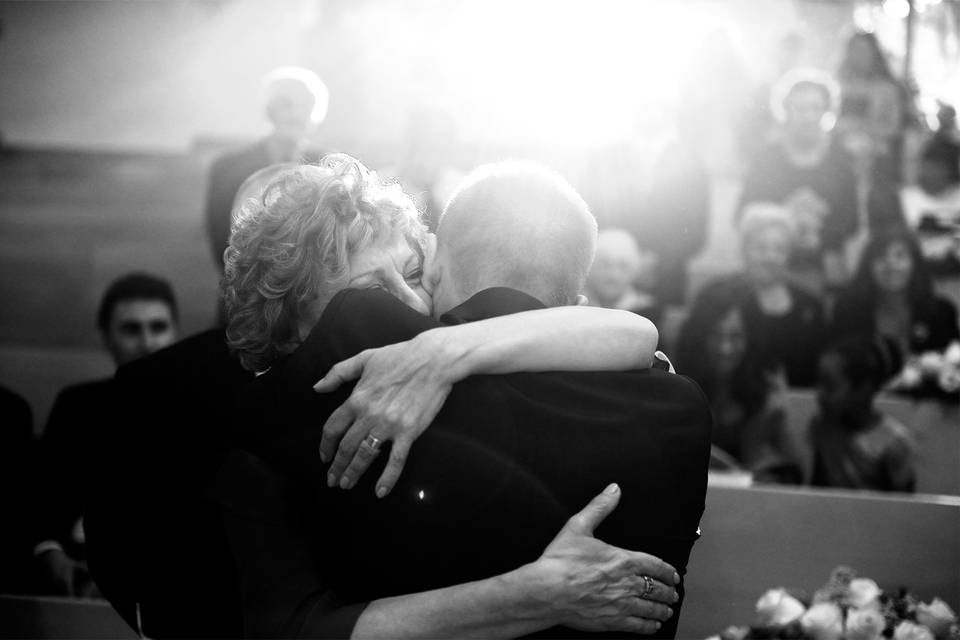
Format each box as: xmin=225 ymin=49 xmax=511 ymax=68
xmin=204 ymin=139 xmax=323 ymax=272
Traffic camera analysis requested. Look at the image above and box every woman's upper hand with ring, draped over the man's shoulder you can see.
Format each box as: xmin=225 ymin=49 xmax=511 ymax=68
xmin=313 ymin=332 xmax=463 ymax=498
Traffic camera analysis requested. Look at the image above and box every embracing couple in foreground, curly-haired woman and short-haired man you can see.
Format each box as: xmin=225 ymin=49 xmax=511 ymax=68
xmin=88 ymin=154 xmax=711 ymax=638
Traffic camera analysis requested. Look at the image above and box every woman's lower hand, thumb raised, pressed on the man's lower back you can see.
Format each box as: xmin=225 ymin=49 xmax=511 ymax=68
xmin=532 ymin=484 xmax=680 ymax=634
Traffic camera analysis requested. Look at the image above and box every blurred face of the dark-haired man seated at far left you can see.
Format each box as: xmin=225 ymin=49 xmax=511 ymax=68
xmin=103 ymin=299 xmax=177 ymax=367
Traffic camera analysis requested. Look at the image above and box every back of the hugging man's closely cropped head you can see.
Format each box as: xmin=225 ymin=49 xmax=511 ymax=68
xmin=435 ymin=161 xmax=597 ymax=312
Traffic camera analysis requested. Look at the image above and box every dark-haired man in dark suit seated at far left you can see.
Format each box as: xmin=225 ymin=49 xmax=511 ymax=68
xmin=35 ymin=273 xmax=177 ymax=595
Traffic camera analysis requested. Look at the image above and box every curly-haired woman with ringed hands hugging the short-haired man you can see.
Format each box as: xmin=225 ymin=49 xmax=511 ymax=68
xmin=223 ymin=155 xmax=679 ymax=637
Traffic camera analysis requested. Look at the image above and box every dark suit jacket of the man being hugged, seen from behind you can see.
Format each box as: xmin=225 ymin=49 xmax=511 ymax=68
xmin=219 ymin=289 xmax=711 ymax=636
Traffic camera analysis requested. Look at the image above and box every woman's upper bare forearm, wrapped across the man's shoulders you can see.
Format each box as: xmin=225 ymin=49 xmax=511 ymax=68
xmin=416 ymin=306 xmax=659 ymax=381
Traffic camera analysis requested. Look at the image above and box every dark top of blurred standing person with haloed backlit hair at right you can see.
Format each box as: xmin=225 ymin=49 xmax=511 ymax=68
xmin=737 ymin=144 xmax=859 ymax=268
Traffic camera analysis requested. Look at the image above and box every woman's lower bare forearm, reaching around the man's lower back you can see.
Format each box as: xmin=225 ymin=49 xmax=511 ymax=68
xmin=350 ymin=565 xmax=558 ymax=638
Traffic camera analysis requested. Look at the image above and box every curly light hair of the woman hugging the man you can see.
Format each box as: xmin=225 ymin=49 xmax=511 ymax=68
xmin=221 ymin=154 xmax=427 ymax=371
